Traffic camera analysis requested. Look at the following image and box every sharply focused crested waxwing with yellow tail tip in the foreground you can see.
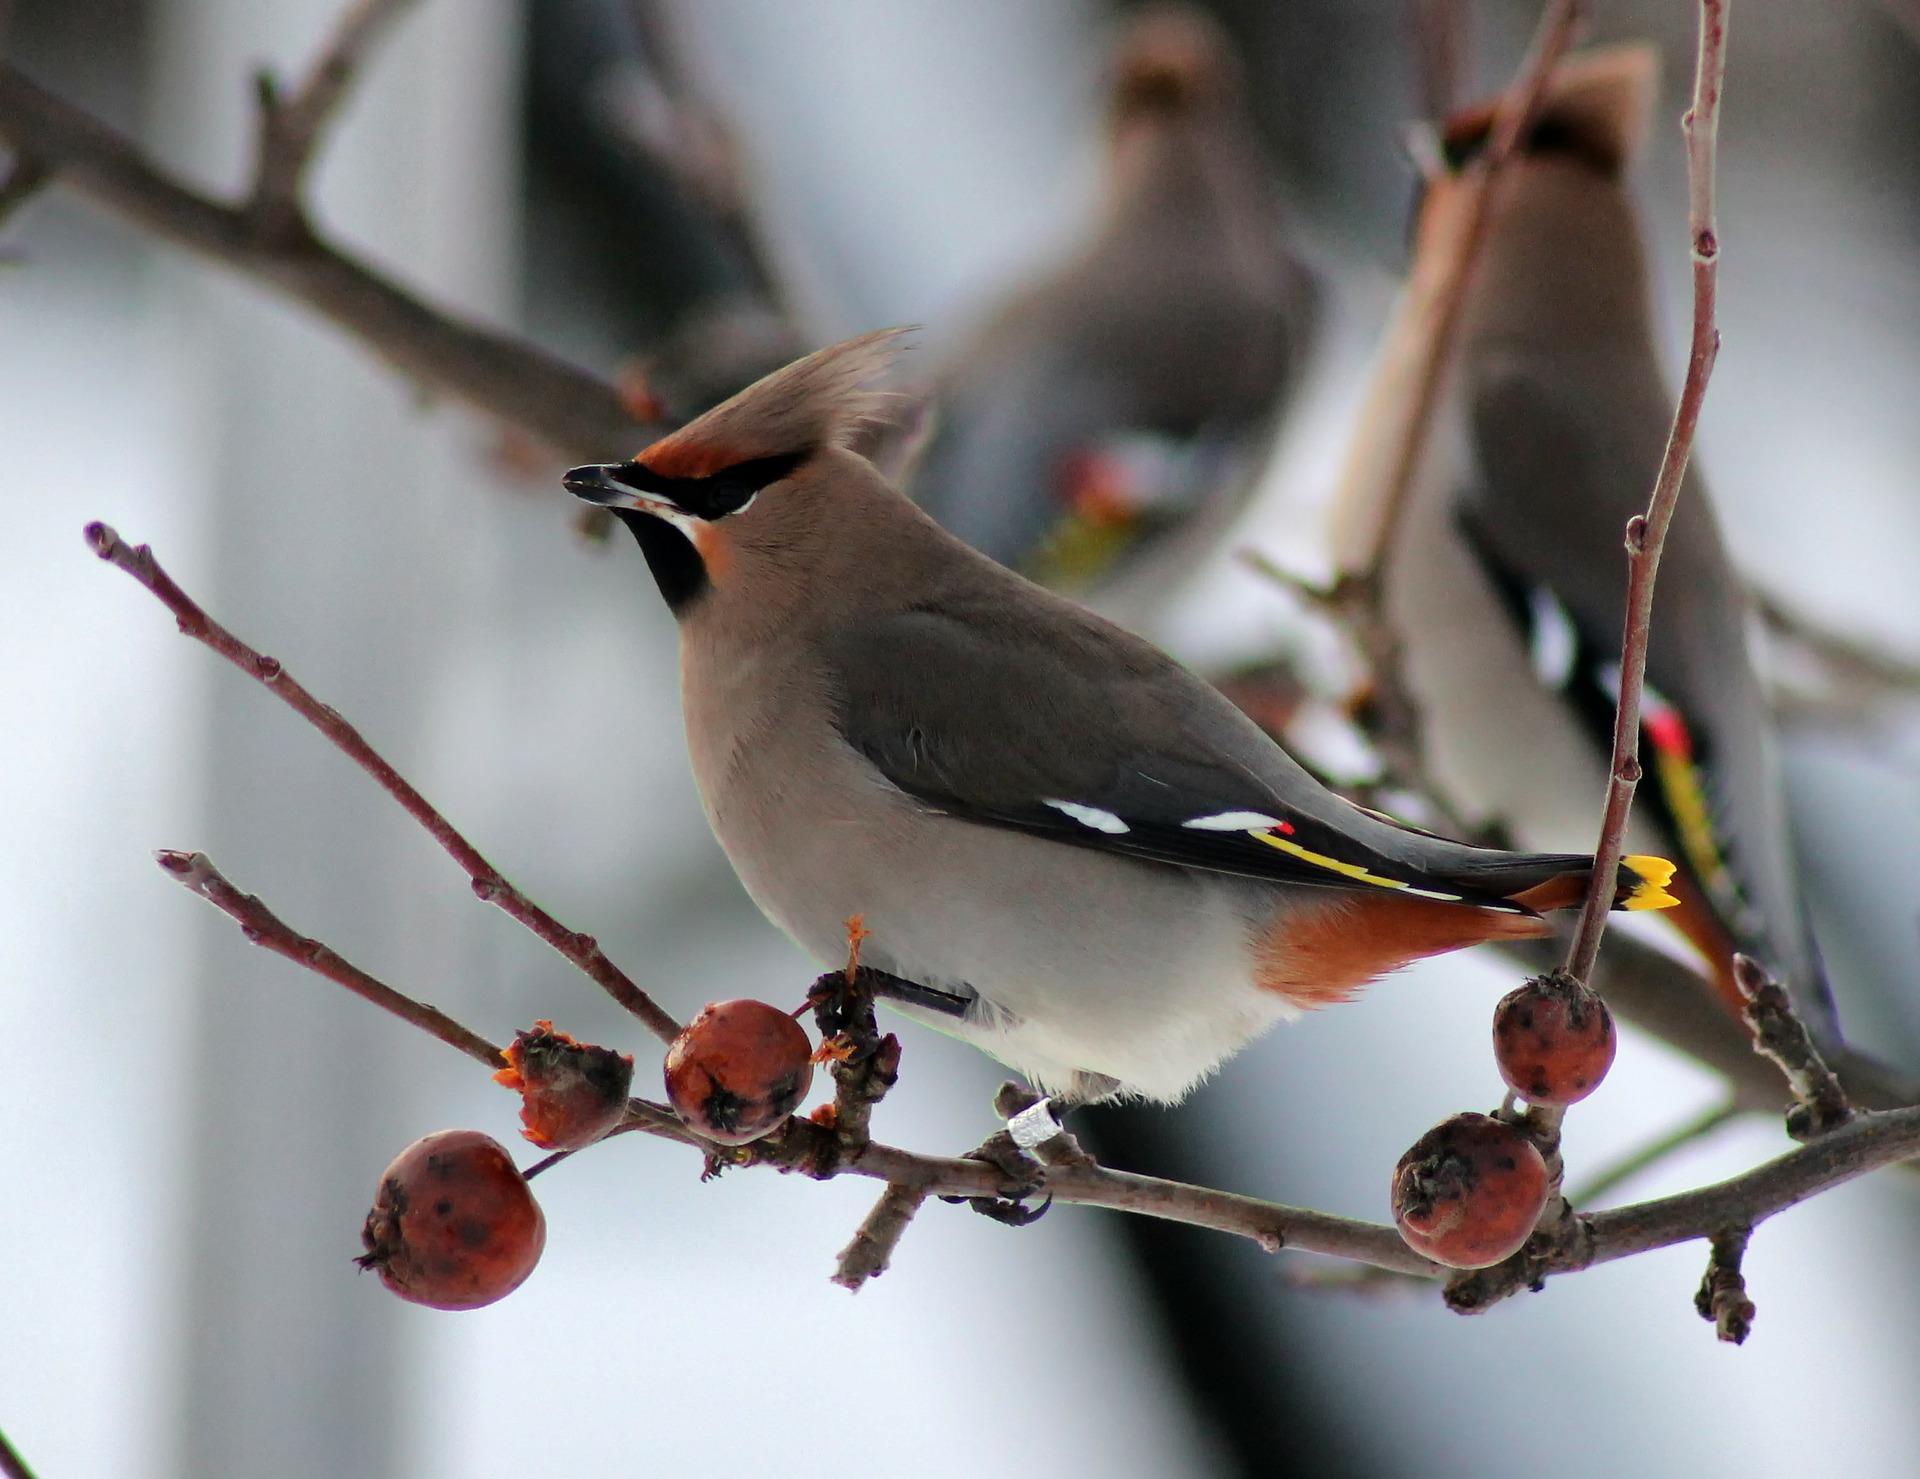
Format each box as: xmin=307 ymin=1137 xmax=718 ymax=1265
xmin=564 ymin=330 xmax=1672 ymax=1101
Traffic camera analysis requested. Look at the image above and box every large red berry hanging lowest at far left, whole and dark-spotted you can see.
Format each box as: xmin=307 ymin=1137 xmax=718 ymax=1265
xmin=353 ymin=1129 xmax=547 ymax=1310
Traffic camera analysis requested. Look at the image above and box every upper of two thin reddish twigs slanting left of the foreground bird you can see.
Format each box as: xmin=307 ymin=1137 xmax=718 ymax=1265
xmin=86 ymin=522 xmax=680 ymax=1043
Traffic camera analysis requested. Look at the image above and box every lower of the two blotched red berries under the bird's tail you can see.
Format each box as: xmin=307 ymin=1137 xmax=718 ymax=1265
xmin=1394 ymin=1114 xmax=1548 ymax=1268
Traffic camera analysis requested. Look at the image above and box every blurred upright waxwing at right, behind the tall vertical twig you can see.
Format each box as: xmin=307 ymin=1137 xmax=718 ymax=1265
xmin=1334 ymin=46 xmax=1899 ymax=1097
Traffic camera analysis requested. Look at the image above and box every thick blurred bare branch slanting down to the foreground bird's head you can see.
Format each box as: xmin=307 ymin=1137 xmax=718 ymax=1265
xmin=0 ymin=61 xmax=649 ymax=457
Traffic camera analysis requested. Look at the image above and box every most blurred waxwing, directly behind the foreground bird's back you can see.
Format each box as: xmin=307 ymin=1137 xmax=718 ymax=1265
xmin=908 ymin=6 xmax=1311 ymax=588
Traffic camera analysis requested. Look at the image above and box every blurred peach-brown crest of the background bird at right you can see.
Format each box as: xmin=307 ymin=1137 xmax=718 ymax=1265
xmin=1442 ymin=42 xmax=1661 ymax=175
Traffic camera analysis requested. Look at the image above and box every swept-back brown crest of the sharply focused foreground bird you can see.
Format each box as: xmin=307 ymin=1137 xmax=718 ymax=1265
xmin=634 ymin=328 xmax=912 ymax=478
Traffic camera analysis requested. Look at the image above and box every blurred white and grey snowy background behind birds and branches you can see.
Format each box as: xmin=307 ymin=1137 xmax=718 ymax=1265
xmin=0 ymin=0 xmax=1920 ymax=1477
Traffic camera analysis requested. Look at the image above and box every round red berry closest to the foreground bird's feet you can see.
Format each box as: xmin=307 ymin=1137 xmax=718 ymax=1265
xmin=666 ymin=1001 xmax=814 ymax=1145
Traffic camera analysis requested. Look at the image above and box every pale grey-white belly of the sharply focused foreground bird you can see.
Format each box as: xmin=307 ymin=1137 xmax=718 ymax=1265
xmin=703 ymin=706 xmax=1296 ymax=1101
